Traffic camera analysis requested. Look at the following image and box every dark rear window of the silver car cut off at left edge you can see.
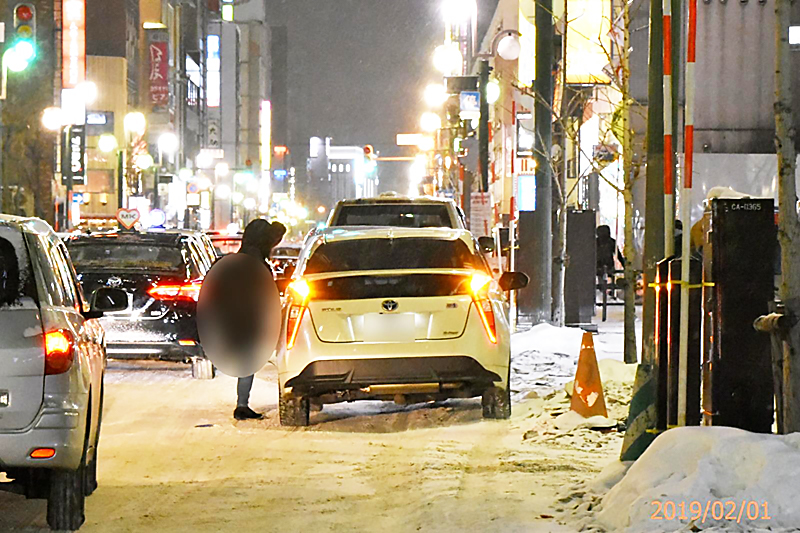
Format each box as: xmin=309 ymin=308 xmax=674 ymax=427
xmin=0 ymin=227 xmax=37 ymax=308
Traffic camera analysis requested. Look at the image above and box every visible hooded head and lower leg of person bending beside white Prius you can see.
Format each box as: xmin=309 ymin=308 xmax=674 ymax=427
xmin=233 ymin=218 xmax=286 ymax=420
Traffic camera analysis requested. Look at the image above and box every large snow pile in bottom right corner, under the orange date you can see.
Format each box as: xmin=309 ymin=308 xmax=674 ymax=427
xmin=561 ymin=427 xmax=800 ymax=533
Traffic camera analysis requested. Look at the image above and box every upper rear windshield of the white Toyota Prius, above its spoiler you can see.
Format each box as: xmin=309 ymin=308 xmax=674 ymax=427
xmin=304 ymin=238 xmax=483 ymax=274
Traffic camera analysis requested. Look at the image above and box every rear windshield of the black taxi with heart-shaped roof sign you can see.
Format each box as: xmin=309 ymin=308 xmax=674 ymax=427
xmin=69 ymin=242 xmax=186 ymax=272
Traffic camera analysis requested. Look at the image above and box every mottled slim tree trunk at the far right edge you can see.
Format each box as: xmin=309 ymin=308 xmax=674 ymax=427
xmin=776 ymin=0 xmax=800 ymax=433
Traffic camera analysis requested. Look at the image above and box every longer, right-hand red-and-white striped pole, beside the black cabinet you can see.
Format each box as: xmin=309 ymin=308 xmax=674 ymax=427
xmin=678 ymin=0 xmax=697 ymax=426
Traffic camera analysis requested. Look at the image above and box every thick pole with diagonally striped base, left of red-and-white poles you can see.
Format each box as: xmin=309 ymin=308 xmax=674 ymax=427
xmin=621 ymin=0 xmax=664 ymax=461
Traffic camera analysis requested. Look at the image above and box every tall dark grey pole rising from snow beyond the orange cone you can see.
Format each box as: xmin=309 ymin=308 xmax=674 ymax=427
xmin=531 ymin=0 xmax=555 ymax=323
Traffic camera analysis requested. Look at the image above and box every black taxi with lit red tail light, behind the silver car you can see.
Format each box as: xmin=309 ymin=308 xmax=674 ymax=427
xmin=67 ymin=231 xmax=214 ymax=379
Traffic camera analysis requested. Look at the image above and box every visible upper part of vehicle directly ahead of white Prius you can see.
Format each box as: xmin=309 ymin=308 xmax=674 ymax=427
xmin=327 ymin=193 xmax=467 ymax=229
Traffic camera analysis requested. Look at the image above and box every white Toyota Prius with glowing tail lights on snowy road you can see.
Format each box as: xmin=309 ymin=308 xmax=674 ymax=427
xmin=275 ymin=227 xmax=528 ymax=426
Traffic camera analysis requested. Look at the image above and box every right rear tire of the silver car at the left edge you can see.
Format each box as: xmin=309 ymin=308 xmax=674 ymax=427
xmin=47 ymin=440 xmax=88 ymax=531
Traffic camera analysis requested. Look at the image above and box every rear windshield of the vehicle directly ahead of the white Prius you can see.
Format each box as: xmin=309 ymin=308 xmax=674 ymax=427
xmin=333 ymin=204 xmax=453 ymax=228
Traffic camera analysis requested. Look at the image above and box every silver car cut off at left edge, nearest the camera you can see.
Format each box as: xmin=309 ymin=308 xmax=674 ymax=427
xmin=0 ymin=215 xmax=125 ymax=530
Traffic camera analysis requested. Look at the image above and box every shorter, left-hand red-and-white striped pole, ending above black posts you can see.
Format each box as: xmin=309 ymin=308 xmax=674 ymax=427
xmin=661 ymin=0 xmax=675 ymax=257
